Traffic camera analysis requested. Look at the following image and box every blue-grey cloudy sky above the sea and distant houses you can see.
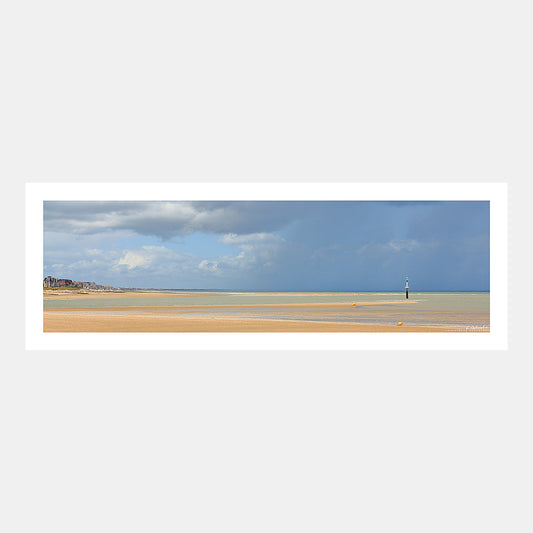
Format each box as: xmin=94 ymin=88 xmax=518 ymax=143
xmin=43 ymin=201 xmax=489 ymax=292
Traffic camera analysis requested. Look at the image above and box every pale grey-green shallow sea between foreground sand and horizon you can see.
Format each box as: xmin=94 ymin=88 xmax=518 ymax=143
xmin=44 ymin=291 xmax=490 ymax=331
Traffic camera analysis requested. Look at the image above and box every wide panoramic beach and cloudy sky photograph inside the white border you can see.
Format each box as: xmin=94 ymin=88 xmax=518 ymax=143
xmin=43 ymin=200 xmax=490 ymax=333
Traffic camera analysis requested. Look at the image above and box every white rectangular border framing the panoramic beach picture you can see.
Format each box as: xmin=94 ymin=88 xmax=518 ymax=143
xmin=25 ymin=182 xmax=508 ymax=350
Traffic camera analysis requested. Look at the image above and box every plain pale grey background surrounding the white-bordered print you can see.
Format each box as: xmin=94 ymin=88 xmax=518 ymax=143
xmin=0 ymin=2 xmax=533 ymax=533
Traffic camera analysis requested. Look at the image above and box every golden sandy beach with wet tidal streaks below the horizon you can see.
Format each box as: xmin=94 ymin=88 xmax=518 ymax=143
xmin=43 ymin=291 xmax=490 ymax=333
